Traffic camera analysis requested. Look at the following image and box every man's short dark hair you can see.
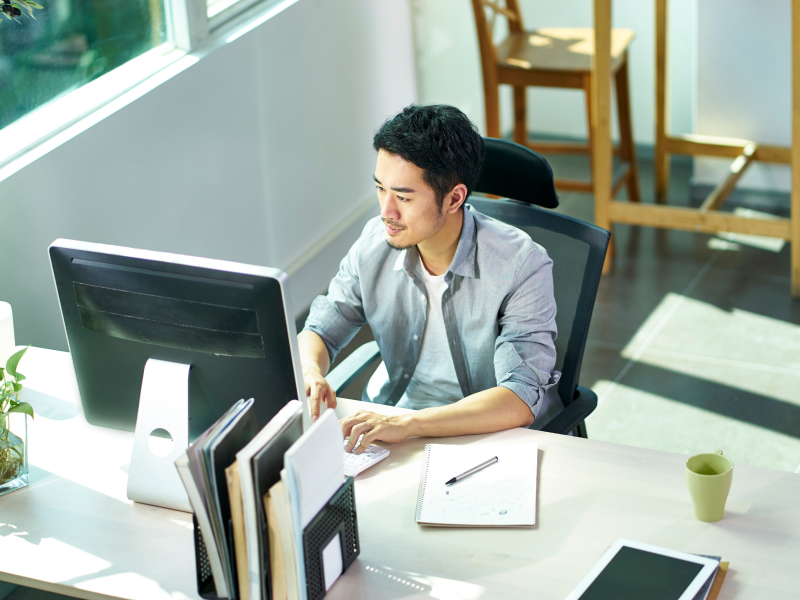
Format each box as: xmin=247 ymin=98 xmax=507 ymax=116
xmin=372 ymin=104 xmax=484 ymax=210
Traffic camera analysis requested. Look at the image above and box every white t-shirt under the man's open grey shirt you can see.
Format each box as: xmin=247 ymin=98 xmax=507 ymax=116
xmin=367 ymin=261 xmax=464 ymax=410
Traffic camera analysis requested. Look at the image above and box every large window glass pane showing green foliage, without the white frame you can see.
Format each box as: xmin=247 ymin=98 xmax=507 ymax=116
xmin=0 ymin=0 xmax=167 ymax=129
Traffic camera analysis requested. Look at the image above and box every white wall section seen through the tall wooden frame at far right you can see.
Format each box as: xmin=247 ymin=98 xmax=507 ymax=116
xmin=695 ymin=0 xmax=792 ymax=192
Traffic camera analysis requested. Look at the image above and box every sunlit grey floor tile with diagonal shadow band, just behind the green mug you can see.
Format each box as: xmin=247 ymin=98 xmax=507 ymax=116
xmin=586 ymin=354 xmax=800 ymax=471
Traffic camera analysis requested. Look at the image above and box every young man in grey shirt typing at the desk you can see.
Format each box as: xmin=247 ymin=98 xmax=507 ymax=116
xmin=298 ymin=105 xmax=560 ymax=453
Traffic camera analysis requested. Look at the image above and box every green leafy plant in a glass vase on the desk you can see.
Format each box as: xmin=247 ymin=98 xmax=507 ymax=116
xmin=0 ymin=348 xmax=33 ymax=496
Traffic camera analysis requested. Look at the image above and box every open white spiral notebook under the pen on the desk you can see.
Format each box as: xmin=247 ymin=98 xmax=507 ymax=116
xmin=417 ymin=444 xmax=539 ymax=527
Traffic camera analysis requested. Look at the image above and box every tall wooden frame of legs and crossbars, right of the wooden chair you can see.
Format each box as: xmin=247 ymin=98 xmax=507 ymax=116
xmin=593 ymin=0 xmax=800 ymax=297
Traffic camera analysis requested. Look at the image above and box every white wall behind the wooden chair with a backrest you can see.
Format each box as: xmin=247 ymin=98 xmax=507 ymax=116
xmin=413 ymin=0 xmax=692 ymax=144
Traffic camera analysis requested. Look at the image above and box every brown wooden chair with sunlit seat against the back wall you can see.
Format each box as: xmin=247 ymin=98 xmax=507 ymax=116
xmin=472 ymin=0 xmax=640 ymax=202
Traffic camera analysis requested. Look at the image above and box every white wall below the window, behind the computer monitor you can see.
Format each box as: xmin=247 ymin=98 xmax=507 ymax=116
xmin=0 ymin=0 xmax=416 ymax=349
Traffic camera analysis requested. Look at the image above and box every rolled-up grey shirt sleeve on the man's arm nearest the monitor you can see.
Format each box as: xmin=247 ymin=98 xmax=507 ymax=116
xmin=303 ymin=240 xmax=366 ymax=362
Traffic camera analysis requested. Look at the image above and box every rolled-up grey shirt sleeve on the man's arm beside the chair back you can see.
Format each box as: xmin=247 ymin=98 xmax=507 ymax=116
xmin=494 ymin=247 xmax=561 ymax=418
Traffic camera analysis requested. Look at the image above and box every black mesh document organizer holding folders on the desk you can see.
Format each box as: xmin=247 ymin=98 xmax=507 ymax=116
xmin=194 ymin=477 xmax=360 ymax=600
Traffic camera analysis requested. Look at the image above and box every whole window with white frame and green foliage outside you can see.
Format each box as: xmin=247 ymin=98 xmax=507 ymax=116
xmin=0 ymin=0 xmax=288 ymax=171
